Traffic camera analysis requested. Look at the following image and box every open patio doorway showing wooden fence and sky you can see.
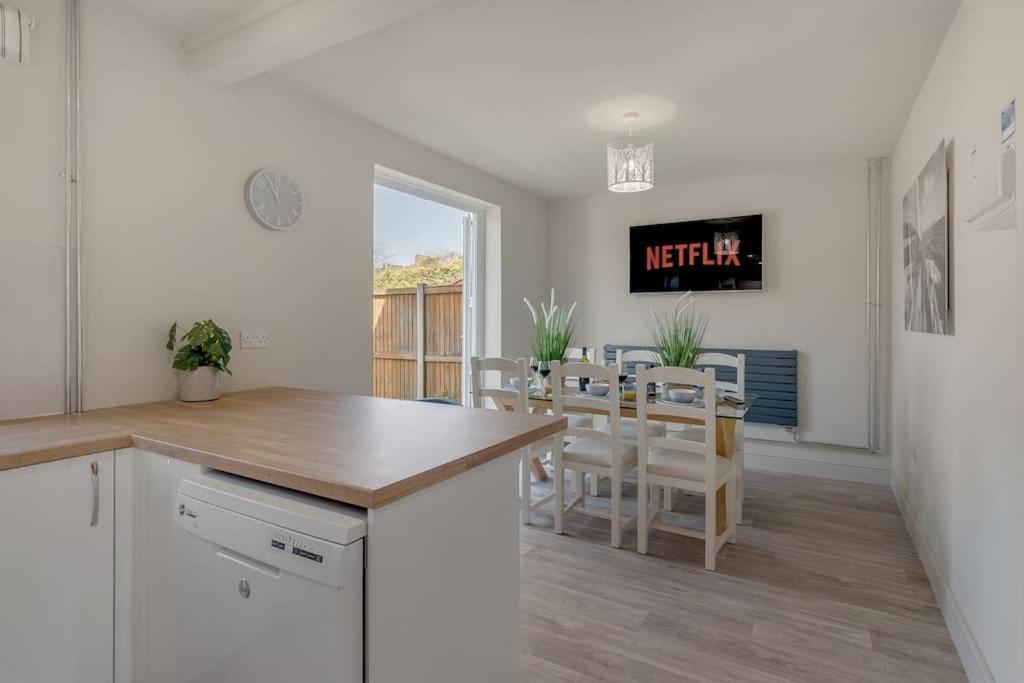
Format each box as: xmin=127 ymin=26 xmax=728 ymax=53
xmin=373 ymin=172 xmax=481 ymax=403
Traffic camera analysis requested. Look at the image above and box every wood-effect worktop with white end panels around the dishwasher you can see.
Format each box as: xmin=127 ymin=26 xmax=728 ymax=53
xmin=0 ymin=388 xmax=563 ymax=683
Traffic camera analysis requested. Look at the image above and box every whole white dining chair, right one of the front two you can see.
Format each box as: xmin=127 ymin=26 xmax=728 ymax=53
xmin=637 ymin=368 xmax=736 ymax=571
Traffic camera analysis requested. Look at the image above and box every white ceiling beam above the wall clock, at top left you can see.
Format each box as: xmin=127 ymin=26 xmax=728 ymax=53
xmin=186 ymin=0 xmax=449 ymax=87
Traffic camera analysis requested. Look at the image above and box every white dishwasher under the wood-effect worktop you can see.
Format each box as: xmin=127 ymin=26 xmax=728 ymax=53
xmin=173 ymin=472 xmax=367 ymax=683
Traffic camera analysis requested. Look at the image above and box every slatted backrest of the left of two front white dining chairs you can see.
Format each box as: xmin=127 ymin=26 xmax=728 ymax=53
xmin=549 ymin=360 xmax=622 ymax=443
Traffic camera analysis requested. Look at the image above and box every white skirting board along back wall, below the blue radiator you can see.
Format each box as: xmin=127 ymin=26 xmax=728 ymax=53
xmin=743 ymin=439 xmax=891 ymax=486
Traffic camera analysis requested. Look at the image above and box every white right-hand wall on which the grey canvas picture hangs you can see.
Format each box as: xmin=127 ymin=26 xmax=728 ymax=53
xmin=891 ymin=0 xmax=1024 ymax=683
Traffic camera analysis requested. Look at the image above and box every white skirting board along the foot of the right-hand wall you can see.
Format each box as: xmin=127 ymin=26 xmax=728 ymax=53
xmin=891 ymin=472 xmax=995 ymax=683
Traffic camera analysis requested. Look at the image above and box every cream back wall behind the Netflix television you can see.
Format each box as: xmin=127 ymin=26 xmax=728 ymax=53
xmin=551 ymin=161 xmax=868 ymax=447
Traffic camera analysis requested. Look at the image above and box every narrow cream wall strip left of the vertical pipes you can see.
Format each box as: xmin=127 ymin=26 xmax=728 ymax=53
xmin=0 ymin=0 xmax=65 ymax=419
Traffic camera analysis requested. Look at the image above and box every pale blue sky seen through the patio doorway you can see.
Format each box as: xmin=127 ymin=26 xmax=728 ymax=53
xmin=374 ymin=185 xmax=466 ymax=265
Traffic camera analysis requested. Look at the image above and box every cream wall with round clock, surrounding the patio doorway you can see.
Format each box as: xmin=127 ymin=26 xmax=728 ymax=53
xmin=70 ymin=0 xmax=547 ymax=408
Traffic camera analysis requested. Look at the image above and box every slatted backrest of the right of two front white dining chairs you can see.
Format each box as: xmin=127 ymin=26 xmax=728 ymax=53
xmin=637 ymin=367 xmax=718 ymax=485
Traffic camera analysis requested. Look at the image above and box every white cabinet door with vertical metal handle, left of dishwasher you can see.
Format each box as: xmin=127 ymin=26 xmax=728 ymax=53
xmin=0 ymin=453 xmax=114 ymax=683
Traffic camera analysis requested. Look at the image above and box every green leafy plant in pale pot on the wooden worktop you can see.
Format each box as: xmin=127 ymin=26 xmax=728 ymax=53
xmin=167 ymin=321 xmax=231 ymax=401
